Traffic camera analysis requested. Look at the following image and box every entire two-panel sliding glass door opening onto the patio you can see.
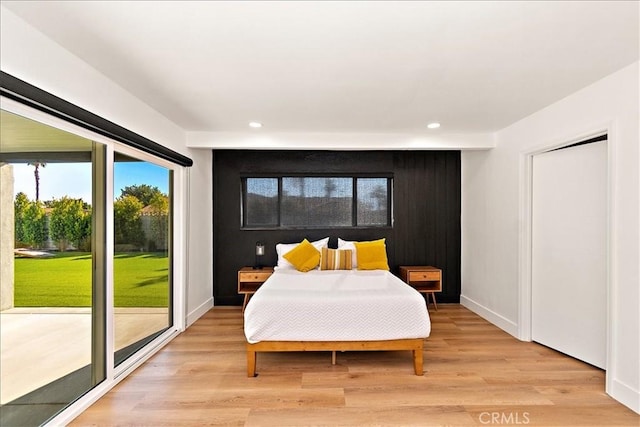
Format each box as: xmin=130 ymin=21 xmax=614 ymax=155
xmin=0 ymin=104 xmax=176 ymax=425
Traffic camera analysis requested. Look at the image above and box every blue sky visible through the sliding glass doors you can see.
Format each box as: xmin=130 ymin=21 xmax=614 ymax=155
xmin=13 ymin=162 xmax=169 ymax=204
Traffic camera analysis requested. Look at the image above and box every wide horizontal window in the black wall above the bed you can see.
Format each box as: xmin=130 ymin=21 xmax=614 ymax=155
xmin=242 ymin=176 xmax=392 ymax=228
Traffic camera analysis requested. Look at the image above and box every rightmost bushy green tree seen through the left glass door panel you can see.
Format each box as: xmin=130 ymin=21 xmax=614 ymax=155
xmin=49 ymin=196 xmax=91 ymax=251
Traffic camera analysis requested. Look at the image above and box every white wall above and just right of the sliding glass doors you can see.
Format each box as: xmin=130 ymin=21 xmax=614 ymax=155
xmin=0 ymin=7 xmax=213 ymax=324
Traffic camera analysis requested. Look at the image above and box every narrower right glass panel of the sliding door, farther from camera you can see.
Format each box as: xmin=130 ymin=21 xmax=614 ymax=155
xmin=113 ymin=152 xmax=172 ymax=365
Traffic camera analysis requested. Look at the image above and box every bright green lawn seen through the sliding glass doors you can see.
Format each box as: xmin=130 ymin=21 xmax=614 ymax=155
xmin=14 ymin=252 xmax=169 ymax=307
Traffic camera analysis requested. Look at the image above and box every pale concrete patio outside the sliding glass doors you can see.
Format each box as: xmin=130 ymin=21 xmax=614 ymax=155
xmin=0 ymin=307 xmax=168 ymax=405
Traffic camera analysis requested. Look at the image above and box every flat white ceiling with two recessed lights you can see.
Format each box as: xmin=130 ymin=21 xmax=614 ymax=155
xmin=2 ymin=1 xmax=640 ymax=134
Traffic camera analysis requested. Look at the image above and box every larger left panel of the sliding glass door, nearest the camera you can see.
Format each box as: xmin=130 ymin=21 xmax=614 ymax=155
xmin=0 ymin=111 xmax=106 ymax=425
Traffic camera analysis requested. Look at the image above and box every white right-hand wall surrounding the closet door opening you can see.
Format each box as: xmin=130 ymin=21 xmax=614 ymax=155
xmin=462 ymin=62 xmax=640 ymax=412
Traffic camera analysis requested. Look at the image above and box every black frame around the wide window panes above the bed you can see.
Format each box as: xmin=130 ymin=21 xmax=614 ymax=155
xmin=240 ymin=173 xmax=393 ymax=230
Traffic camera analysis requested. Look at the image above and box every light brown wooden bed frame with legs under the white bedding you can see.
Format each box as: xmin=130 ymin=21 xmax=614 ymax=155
xmin=247 ymin=338 xmax=424 ymax=377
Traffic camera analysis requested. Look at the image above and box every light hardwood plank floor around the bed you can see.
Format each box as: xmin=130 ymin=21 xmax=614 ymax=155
xmin=72 ymin=304 xmax=640 ymax=426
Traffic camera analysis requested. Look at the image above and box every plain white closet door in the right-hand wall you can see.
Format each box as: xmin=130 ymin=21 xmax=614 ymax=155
xmin=531 ymin=141 xmax=607 ymax=368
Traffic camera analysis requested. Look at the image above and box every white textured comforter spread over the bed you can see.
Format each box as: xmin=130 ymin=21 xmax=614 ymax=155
xmin=244 ymin=270 xmax=431 ymax=343
